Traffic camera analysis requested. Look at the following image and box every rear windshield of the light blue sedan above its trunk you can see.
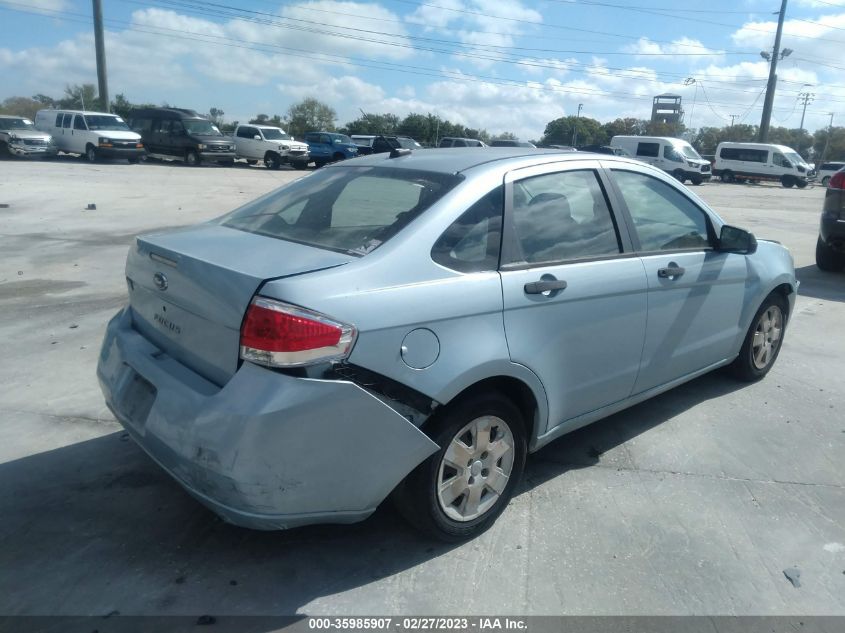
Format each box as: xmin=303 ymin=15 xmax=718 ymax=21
xmin=217 ymin=166 xmax=463 ymax=256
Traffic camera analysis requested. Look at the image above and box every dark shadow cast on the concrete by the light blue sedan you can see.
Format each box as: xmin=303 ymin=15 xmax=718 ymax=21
xmin=0 ymin=373 xmax=741 ymax=615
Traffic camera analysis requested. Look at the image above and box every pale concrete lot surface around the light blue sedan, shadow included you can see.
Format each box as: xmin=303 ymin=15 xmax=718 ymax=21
xmin=0 ymin=159 xmax=845 ymax=615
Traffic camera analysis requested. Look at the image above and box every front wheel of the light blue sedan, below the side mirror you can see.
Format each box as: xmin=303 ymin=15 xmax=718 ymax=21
xmin=730 ymin=293 xmax=788 ymax=382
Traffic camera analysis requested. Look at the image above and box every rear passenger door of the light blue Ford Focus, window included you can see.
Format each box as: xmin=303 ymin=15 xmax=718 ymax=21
xmin=501 ymin=161 xmax=647 ymax=433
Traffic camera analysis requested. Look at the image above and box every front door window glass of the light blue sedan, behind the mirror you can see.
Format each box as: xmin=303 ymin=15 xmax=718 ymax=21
xmin=613 ymin=170 xmax=711 ymax=251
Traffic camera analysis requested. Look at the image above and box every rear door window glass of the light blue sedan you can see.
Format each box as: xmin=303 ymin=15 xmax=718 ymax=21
xmin=513 ymin=169 xmax=620 ymax=264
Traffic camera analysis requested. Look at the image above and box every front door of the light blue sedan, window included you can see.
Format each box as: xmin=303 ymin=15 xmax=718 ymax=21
xmin=610 ymin=165 xmax=748 ymax=393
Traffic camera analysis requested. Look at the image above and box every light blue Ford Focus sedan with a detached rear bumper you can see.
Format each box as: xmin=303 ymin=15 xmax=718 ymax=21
xmin=97 ymin=148 xmax=797 ymax=540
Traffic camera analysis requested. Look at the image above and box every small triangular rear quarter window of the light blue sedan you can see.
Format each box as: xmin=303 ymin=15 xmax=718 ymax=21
xmin=431 ymin=186 xmax=505 ymax=272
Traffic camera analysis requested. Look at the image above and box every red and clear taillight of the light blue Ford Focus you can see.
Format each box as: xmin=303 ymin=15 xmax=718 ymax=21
xmin=241 ymin=297 xmax=355 ymax=367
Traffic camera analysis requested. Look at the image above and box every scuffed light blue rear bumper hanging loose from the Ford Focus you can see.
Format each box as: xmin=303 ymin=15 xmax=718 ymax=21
xmin=97 ymin=308 xmax=437 ymax=530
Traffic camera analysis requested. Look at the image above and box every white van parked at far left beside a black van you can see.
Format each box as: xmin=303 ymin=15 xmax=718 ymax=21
xmin=35 ymin=110 xmax=144 ymax=163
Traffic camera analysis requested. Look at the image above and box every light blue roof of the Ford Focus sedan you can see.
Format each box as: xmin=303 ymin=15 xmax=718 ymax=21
xmin=330 ymin=147 xmax=628 ymax=174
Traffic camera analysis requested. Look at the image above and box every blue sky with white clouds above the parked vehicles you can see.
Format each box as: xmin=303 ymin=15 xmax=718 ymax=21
xmin=0 ymin=0 xmax=845 ymax=139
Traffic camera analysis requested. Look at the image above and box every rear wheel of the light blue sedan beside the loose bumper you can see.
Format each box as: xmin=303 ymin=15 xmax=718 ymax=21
xmin=394 ymin=393 xmax=527 ymax=542
